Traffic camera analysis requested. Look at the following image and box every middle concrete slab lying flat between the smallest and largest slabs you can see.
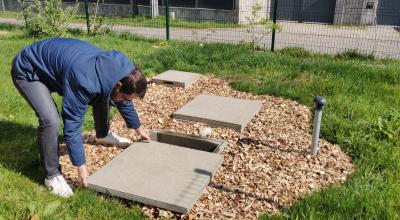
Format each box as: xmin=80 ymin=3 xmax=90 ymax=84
xmin=173 ymin=95 xmax=262 ymax=132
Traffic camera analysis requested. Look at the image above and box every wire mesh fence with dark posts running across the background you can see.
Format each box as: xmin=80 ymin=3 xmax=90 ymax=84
xmin=0 ymin=0 xmax=400 ymax=58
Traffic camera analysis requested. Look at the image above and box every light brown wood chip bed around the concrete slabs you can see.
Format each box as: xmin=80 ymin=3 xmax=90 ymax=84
xmin=60 ymin=76 xmax=354 ymax=219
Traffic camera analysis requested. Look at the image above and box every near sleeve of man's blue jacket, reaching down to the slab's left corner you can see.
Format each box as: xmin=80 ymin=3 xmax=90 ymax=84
xmin=61 ymin=81 xmax=90 ymax=166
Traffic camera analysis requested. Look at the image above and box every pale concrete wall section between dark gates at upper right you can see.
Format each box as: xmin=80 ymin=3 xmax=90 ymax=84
xmin=333 ymin=0 xmax=378 ymax=25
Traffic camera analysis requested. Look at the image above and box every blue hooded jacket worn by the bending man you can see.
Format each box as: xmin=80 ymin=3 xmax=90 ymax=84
xmin=13 ymin=38 xmax=140 ymax=166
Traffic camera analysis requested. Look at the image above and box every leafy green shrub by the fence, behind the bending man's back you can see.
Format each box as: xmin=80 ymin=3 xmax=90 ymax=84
xmin=23 ymin=0 xmax=77 ymax=37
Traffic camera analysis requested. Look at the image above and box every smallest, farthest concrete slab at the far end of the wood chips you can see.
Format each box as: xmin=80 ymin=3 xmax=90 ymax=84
xmin=153 ymin=70 xmax=202 ymax=88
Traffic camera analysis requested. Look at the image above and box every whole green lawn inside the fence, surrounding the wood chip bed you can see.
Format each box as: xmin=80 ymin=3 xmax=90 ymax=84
xmin=0 ymin=29 xmax=400 ymax=219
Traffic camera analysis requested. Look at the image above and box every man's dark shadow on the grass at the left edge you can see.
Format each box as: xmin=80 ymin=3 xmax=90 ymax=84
xmin=0 ymin=120 xmax=45 ymax=184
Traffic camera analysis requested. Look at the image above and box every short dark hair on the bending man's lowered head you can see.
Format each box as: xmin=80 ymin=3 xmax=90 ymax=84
xmin=119 ymin=68 xmax=147 ymax=98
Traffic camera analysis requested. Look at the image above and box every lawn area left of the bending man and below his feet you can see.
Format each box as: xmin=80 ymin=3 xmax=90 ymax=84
xmin=0 ymin=30 xmax=148 ymax=219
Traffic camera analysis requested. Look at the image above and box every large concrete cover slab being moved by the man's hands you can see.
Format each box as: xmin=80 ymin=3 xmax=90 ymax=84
xmin=88 ymin=142 xmax=223 ymax=213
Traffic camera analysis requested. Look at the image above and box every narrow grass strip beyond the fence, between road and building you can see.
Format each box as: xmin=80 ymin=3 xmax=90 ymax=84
xmin=0 ymin=11 xmax=243 ymax=29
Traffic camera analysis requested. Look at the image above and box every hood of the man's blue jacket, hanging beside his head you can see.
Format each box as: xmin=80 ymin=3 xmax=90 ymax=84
xmin=96 ymin=50 xmax=136 ymax=98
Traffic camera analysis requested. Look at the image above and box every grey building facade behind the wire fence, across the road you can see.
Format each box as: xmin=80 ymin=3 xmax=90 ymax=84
xmin=4 ymin=0 xmax=400 ymax=25
